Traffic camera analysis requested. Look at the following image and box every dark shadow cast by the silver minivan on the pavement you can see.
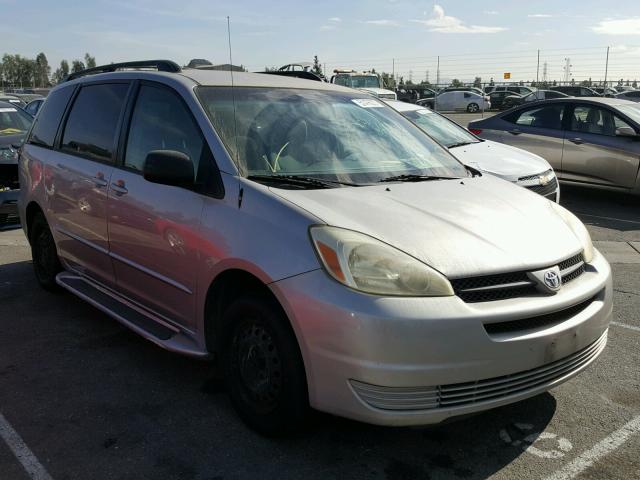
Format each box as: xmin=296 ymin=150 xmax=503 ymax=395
xmin=0 ymin=261 xmax=556 ymax=480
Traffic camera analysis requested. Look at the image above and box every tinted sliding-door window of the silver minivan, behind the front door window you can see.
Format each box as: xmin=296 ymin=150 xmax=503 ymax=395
xmin=61 ymin=83 xmax=129 ymax=162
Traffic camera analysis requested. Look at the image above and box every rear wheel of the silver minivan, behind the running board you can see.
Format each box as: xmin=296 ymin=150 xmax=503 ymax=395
xmin=30 ymin=212 xmax=62 ymax=291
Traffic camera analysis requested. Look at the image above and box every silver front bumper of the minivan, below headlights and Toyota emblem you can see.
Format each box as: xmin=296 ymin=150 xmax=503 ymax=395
xmin=271 ymin=252 xmax=612 ymax=425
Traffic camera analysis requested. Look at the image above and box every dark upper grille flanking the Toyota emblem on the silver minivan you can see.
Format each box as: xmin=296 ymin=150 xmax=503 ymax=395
xmin=451 ymin=252 xmax=585 ymax=303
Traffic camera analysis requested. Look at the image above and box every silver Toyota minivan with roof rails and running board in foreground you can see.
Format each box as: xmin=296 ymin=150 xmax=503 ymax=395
xmin=19 ymin=61 xmax=612 ymax=434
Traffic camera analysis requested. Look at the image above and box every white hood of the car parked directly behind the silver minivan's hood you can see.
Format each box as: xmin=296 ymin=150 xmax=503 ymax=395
xmin=449 ymin=140 xmax=551 ymax=181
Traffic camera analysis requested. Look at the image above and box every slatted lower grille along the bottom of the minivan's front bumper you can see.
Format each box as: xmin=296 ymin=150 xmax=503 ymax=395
xmin=349 ymin=332 xmax=607 ymax=411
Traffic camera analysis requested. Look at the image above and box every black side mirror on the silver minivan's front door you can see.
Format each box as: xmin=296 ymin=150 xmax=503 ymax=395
xmin=142 ymin=150 xmax=194 ymax=188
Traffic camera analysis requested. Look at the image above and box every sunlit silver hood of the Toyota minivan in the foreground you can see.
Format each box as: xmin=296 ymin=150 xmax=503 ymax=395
xmin=271 ymin=175 xmax=581 ymax=278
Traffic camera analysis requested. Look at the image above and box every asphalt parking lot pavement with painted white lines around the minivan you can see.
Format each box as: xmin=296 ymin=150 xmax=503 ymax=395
xmin=0 ymin=188 xmax=640 ymax=480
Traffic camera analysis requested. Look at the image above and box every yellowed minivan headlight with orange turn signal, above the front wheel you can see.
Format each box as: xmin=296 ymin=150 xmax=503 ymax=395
xmin=310 ymin=226 xmax=453 ymax=297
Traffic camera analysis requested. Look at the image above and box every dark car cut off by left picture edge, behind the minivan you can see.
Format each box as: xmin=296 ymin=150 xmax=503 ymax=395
xmin=0 ymin=101 xmax=33 ymax=230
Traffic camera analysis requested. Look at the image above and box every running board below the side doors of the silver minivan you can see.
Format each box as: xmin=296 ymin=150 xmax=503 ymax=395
xmin=56 ymin=272 xmax=208 ymax=357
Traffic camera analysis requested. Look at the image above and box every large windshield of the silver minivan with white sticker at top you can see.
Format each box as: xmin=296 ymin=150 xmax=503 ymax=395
xmin=196 ymin=87 xmax=468 ymax=184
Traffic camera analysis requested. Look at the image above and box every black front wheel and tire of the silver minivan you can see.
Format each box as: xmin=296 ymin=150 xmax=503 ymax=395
xmin=222 ymin=295 xmax=310 ymax=436
